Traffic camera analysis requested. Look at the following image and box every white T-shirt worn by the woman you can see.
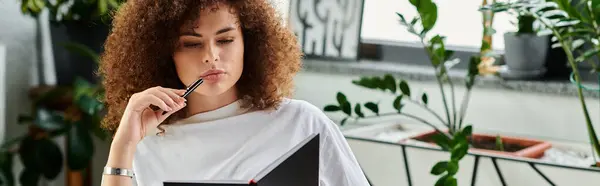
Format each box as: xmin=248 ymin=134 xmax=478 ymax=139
xmin=125 ymin=99 xmax=369 ymax=186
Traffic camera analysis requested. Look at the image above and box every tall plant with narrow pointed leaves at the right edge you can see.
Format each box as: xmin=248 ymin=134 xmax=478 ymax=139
xmin=481 ymin=0 xmax=600 ymax=166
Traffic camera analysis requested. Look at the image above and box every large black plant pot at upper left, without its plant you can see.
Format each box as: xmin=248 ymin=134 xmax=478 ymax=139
xmin=50 ymin=21 xmax=110 ymax=85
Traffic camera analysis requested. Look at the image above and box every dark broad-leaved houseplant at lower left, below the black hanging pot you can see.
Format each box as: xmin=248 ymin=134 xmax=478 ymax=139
xmin=0 ymin=45 xmax=108 ymax=186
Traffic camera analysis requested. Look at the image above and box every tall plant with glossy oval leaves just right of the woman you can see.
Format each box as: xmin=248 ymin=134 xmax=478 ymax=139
xmin=324 ymin=0 xmax=488 ymax=186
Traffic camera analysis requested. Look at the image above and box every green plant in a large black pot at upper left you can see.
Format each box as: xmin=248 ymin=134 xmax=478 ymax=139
xmin=21 ymin=0 xmax=125 ymax=85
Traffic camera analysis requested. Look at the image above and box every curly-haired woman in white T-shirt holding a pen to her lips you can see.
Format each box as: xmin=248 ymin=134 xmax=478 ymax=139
xmin=100 ymin=0 xmax=368 ymax=186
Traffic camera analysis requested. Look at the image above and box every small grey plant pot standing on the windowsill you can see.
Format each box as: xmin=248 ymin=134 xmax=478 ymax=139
xmin=500 ymin=32 xmax=549 ymax=79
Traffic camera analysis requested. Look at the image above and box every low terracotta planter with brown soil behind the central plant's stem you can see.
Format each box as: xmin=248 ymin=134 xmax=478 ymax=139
xmin=412 ymin=131 xmax=552 ymax=159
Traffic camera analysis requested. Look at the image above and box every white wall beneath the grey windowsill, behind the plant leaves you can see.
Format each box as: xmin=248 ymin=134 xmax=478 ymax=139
xmin=296 ymin=72 xmax=600 ymax=143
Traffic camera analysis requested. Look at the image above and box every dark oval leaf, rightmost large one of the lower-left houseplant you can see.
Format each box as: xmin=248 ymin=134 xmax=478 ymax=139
xmin=67 ymin=121 xmax=94 ymax=170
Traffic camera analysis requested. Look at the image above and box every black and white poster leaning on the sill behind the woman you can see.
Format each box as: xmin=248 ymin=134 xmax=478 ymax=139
xmin=288 ymin=0 xmax=364 ymax=60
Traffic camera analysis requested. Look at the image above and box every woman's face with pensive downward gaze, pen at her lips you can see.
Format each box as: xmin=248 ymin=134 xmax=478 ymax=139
xmin=173 ymin=4 xmax=244 ymax=96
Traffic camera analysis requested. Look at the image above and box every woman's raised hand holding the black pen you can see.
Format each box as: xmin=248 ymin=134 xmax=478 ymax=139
xmin=115 ymin=87 xmax=186 ymax=146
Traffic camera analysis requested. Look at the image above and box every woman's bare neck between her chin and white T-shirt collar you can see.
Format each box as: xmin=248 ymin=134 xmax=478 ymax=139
xmin=187 ymin=86 xmax=238 ymax=116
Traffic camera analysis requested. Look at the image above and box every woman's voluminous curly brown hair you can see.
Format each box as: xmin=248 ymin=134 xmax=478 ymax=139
xmin=99 ymin=0 xmax=303 ymax=133
